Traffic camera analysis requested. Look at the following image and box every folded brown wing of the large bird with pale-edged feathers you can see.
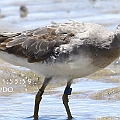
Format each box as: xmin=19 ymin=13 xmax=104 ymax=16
xmin=0 ymin=23 xmax=74 ymax=62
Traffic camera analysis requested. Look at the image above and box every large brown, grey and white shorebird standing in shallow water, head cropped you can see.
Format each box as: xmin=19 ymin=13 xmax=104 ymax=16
xmin=0 ymin=21 xmax=120 ymax=120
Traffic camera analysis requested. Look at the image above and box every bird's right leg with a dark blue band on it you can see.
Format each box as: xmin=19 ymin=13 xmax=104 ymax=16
xmin=62 ymin=80 xmax=72 ymax=120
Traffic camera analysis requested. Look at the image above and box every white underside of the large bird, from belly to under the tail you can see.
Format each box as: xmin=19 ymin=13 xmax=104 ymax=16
xmin=0 ymin=51 xmax=100 ymax=79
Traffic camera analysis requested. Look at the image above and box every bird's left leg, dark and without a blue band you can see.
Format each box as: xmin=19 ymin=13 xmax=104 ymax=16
xmin=34 ymin=77 xmax=51 ymax=120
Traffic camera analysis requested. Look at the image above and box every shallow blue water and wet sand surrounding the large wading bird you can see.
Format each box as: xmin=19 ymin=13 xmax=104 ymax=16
xmin=0 ymin=0 xmax=120 ymax=120
